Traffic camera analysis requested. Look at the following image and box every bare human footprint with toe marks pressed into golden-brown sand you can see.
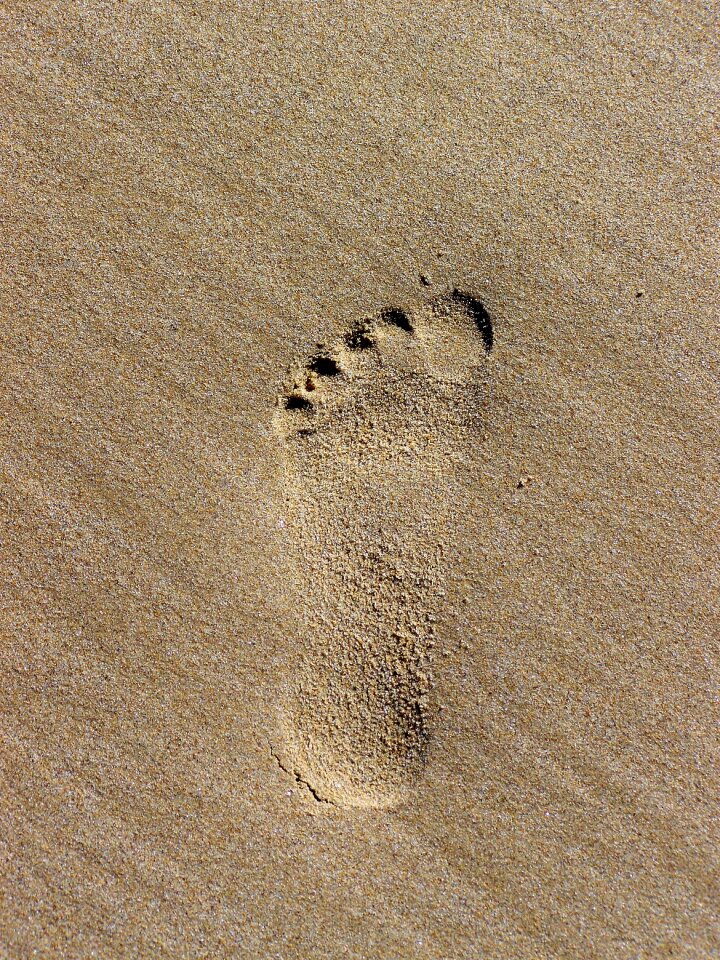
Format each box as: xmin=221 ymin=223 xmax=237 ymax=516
xmin=275 ymin=290 xmax=493 ymax=807
